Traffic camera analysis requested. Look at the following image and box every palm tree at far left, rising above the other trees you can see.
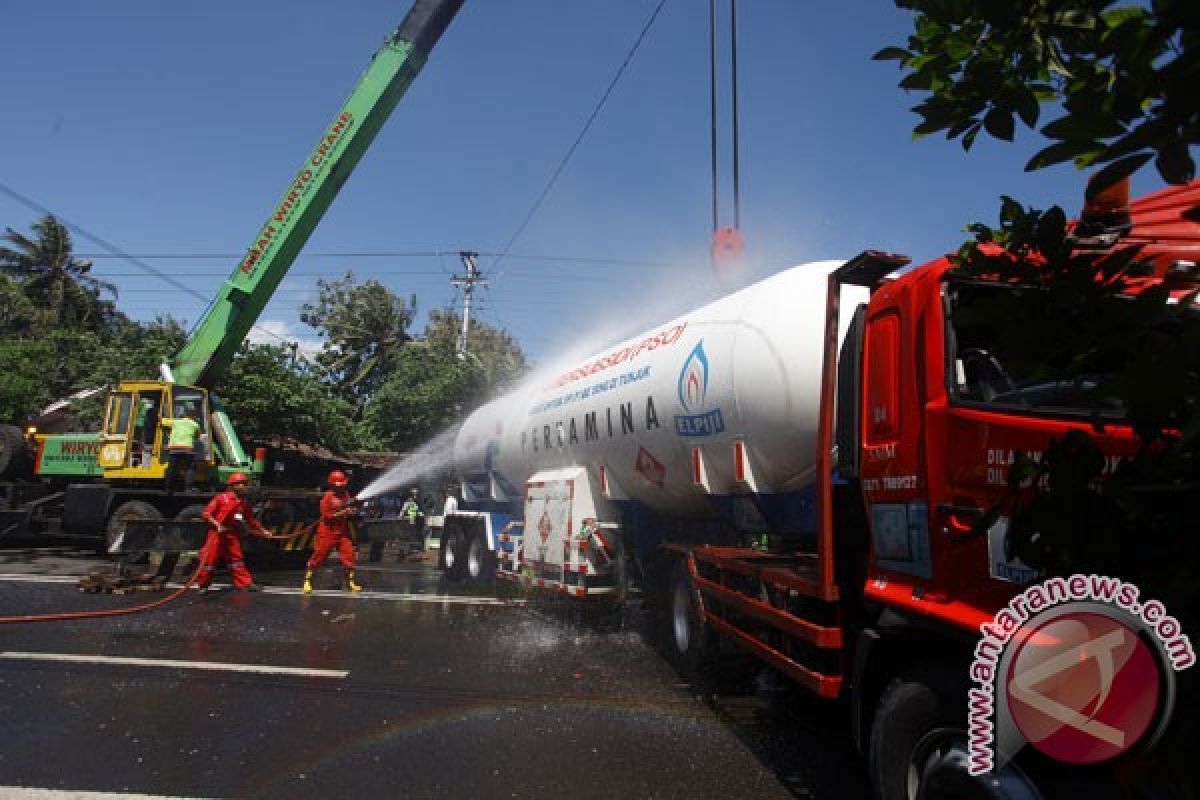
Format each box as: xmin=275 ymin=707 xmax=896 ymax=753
xmin=0 ymin=213 xmax=116 ymax=330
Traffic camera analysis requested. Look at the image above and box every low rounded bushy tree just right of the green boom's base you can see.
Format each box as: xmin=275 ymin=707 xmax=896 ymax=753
xmin=217 ymin=344 xmax=358 ymax=452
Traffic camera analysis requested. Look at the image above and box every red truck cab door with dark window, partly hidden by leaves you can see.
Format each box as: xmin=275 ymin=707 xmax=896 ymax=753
xmin=931 ymin=278 xmax=1135 ymax=607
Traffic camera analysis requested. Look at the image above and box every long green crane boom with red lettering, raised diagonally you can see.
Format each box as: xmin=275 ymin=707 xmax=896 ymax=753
xmin=169 ymin=0 xmax=463 ymax=388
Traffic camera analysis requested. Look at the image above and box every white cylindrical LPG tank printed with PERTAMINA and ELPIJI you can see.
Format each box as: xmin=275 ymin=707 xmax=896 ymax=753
xmin=455 ymin=261 xmax=866 ymax=513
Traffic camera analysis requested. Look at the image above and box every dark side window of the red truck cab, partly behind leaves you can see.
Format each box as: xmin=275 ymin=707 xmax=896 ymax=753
xmin=946 ymin=281 xmax=1166 ymax=420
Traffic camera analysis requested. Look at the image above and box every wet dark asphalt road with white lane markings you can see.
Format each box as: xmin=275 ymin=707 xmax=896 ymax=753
xmin=0 ymin=549 xmax=866 ymax=798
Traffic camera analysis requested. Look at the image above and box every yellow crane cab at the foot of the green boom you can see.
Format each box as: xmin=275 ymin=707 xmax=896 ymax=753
xmin=98 ymin=381 xmax=214 ymax=481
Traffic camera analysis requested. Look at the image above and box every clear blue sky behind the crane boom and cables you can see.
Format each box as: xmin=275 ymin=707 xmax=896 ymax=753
xmin=0 ymin=0 xmax=1159 ymax=361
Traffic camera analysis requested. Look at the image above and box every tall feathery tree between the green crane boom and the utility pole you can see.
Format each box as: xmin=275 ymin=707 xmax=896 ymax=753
xmin=300 ymin=272 xmax=416 ymax=403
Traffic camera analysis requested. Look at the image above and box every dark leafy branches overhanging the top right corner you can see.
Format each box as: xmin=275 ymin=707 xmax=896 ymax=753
xmin=875 ymin=0 xmax=1200 ymax=186
